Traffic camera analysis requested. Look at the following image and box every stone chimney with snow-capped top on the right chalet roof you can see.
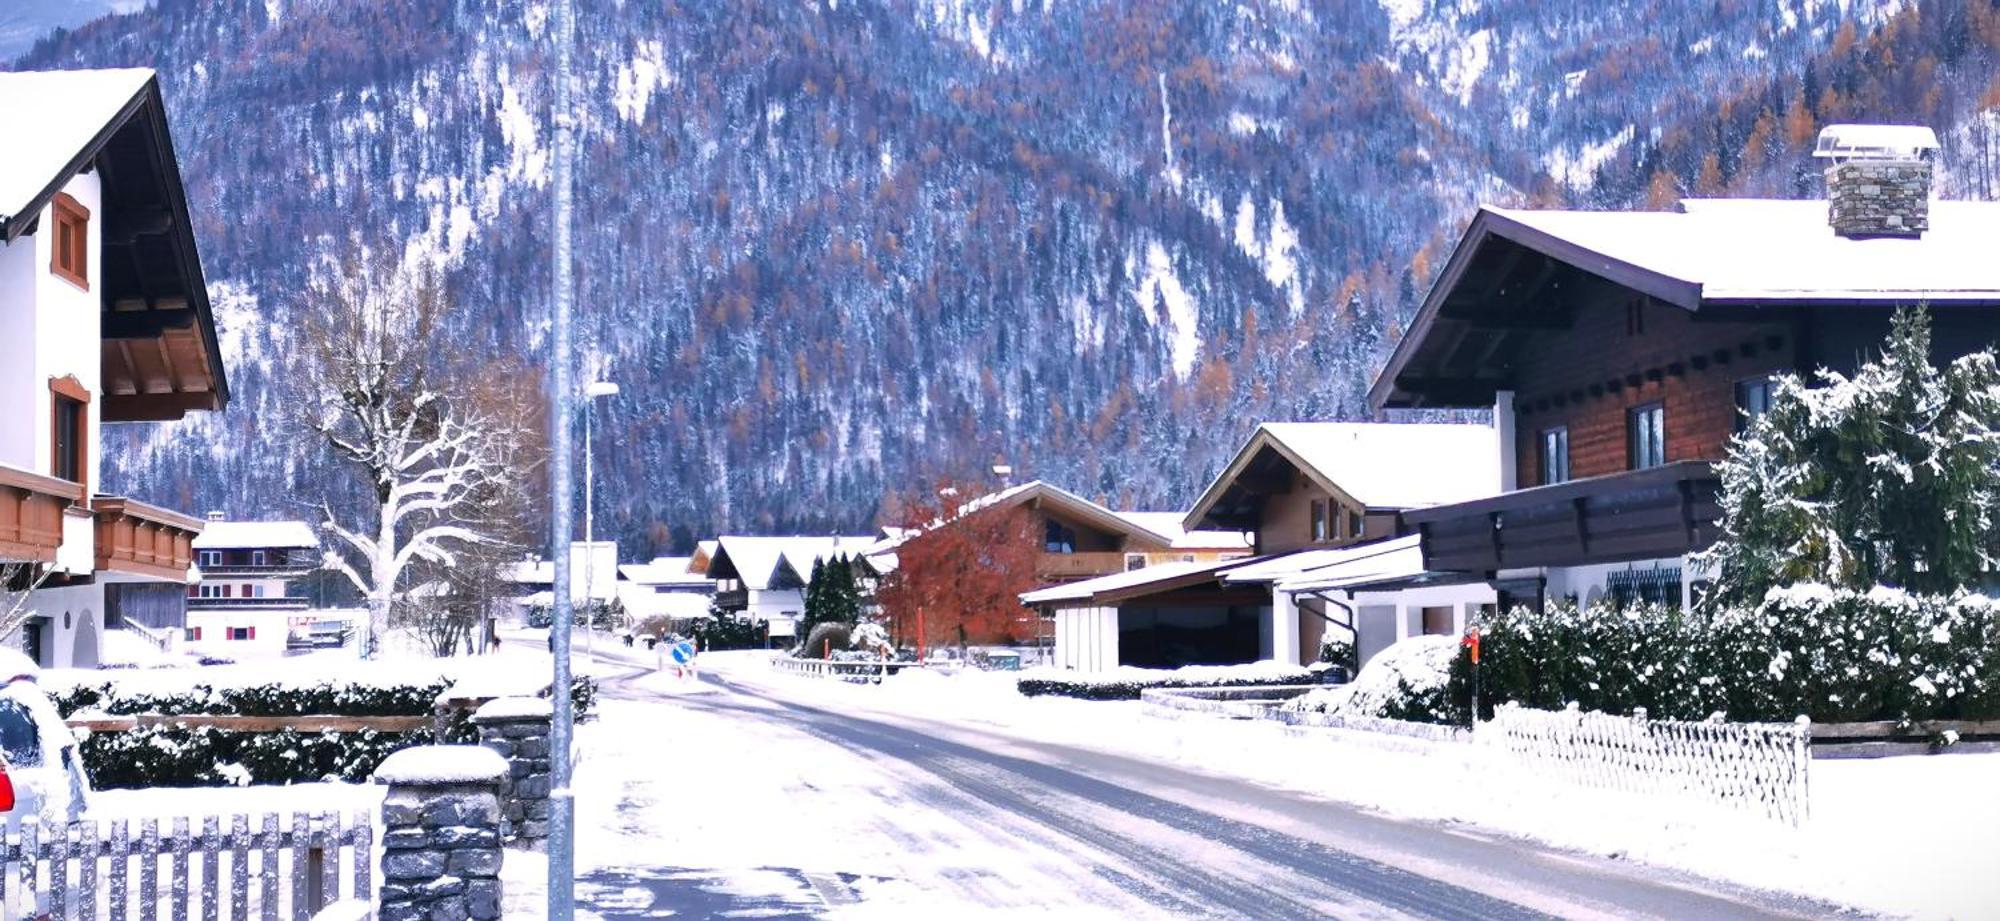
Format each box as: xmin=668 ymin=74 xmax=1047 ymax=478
xmin=1812 ymin=124 xmax=1938 ymax=238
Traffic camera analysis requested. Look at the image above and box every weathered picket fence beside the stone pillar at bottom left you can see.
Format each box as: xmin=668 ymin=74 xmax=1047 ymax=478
xmin=0 ymin=813 xmax=374 ymax=921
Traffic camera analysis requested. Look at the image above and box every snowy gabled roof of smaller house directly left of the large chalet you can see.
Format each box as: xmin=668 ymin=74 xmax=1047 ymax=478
xmin=1184 ymin=422 xmax=1500 ymax=527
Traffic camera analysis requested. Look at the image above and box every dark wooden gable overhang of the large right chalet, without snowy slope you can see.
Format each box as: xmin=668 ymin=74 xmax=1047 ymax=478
xmin=1368 ymin=208 xmax=1702 ymax=408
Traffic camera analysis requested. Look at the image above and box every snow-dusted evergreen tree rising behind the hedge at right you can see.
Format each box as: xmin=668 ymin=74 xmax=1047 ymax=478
xmin=1706 ymin=310 xmax=2000 ymax=605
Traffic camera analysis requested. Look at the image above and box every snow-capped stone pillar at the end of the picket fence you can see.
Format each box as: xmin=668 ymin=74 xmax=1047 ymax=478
xmin=374 ymin=745 xmax=508 ymax=921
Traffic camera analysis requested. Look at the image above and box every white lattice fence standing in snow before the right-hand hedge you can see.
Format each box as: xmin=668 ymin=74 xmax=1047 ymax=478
xmin=1472 ymin=703 xmax=1812 ymax=825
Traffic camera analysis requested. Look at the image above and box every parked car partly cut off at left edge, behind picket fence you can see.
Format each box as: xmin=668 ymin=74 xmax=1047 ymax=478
xmin=0 ymin=657 xmax=90 ymax=829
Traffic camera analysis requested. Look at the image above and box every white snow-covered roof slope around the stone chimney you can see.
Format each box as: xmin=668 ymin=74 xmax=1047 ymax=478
xmin=1486 ymin=198 xmax=2000 ymax=308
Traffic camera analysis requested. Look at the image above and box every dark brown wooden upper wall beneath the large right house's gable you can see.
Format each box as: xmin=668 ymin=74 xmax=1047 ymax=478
xmin=1514 ymin=298 xmax=1800 ymax=487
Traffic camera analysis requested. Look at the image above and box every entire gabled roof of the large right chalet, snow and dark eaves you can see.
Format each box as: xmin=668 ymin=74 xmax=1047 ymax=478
xmin=1368 ymin=198 xmax=2000 ymax=406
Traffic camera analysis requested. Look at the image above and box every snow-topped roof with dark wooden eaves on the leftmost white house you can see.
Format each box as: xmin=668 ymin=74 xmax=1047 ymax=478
xmin=0 ymin=68 xmax=230 ymax=422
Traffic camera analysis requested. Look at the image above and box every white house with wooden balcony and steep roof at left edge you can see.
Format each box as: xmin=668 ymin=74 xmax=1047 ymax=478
xmin=0 ymin=70 xmax=228 ymax=667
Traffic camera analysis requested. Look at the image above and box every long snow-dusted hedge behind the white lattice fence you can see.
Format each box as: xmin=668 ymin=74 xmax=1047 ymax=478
xmin=1452 ymin=585 xmax=2000 ymax=723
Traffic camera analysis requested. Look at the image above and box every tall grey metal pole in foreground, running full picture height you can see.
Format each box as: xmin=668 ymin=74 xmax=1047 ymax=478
xmin=548 ymin=0 xmax=576 ymax=921
